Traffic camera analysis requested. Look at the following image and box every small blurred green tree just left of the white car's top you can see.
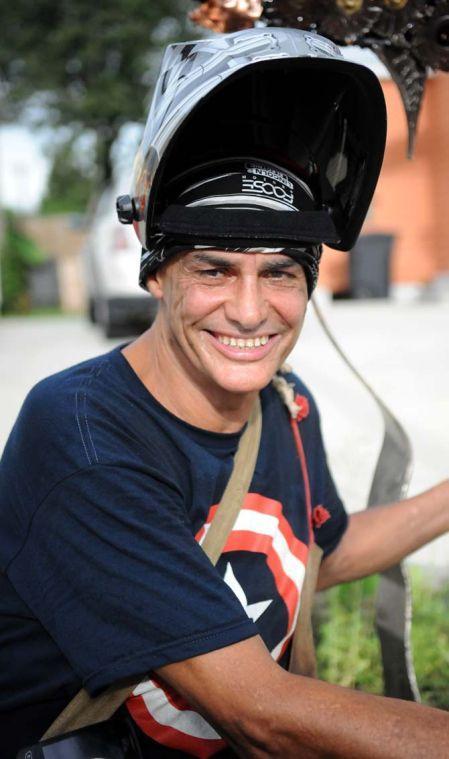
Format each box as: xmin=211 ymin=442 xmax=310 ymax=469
xmin=41 ymin=140 xmax=96 ymax=214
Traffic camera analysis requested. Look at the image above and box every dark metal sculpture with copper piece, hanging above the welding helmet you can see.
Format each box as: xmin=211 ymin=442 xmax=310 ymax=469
xmin=191 ymin=0 xmax=449 ymax=157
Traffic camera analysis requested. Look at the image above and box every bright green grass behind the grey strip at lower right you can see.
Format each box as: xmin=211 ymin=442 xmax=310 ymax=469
xmin=317 ymin=570 xmax=449 ymax=709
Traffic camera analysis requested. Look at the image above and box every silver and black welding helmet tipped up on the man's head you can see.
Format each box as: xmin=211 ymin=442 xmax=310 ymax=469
xmin=117 ymin=28 xmax=386 ymax=290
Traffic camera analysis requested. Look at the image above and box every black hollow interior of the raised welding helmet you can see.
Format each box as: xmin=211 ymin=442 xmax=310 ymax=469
xmin=146 ymin=58 xmax=386 ymax=250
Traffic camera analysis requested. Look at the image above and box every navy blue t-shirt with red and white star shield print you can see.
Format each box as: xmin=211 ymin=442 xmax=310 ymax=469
xmin=0 ymin=348 xmax=347 ymax=756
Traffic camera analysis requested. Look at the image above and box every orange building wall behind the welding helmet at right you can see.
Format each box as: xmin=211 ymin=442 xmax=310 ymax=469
xmin=320 ymin=73 xmax=449 ymax=292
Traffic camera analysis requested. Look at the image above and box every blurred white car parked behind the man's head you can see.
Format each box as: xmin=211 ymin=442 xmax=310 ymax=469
xmin=84 ymin=187 xmax=157 ymax=337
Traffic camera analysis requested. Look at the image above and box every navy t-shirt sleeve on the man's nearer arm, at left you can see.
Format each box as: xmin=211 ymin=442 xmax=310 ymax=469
xmin=8 ymin=465 xmax=257 ymax=694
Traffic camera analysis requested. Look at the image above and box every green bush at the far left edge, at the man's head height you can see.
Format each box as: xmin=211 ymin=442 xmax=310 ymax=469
xmin=0 ymin=213 xmax=45 ymax=313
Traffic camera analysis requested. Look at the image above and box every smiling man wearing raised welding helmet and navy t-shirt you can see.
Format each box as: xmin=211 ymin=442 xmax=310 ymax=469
xmin=0 ymin=25 xmax=449 ymax=759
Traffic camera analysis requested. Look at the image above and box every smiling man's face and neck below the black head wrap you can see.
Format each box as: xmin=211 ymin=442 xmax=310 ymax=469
xmin=123 ymin=249 xmax=308 ymax=432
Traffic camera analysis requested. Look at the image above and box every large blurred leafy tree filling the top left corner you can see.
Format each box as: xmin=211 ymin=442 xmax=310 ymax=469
xmin=0 ymin=0 xmax=198 ymax=183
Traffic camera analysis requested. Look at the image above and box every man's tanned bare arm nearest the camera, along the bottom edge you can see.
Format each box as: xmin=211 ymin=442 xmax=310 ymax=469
xmin=158 ymin=637 xmax=449 ymax=759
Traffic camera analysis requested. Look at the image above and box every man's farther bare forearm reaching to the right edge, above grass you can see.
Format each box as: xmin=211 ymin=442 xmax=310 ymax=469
xmin=318 ymin=480 xmax=449 ymax=590
